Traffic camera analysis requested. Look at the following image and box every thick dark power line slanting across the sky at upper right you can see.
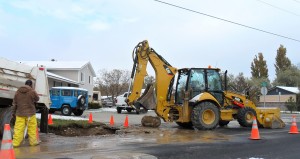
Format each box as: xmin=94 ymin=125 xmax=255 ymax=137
xmin=154 ymin=0 xmax=300 ymax=42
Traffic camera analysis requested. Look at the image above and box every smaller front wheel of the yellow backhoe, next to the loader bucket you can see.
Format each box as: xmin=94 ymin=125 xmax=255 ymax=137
xmin=237 ymin=107 xmax=256 ymax=127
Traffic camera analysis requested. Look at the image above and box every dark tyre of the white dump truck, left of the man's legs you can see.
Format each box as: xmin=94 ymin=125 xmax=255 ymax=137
xmin=0 ymin=107 xmax=16 ymax=138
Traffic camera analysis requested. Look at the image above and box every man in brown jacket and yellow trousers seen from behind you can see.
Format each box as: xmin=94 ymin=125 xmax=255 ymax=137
xmin=12 ymin=80 xmax=39 ymax=147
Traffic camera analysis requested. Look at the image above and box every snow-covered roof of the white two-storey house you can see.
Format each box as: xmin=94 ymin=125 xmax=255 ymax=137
xmin=20 ymin=61 xmax=96 ymax=77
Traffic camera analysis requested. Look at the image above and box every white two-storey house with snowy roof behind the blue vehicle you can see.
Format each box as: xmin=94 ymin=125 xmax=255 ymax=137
xmin=20 ymin=60 xmax=96 ymax=98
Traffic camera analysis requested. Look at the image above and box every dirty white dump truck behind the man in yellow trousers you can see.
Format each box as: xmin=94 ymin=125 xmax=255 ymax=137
xmin=0 ymin=57 xmax=51 ymax=137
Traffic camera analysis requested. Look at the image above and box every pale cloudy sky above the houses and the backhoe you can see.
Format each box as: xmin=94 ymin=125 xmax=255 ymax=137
xmin=0 ymin=0 xmax=300 ymax=80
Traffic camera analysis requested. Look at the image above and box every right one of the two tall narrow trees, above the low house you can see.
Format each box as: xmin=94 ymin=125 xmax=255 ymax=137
xmin=274 ymin=45 xmax=292 ymax=76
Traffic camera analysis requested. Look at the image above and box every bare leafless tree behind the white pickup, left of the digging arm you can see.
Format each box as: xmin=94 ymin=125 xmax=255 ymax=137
xmin=96 ymin=69 xmax=130 ymax=102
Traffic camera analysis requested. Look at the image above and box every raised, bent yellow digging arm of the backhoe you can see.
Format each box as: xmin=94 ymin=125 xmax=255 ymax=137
xmin=126 ymin=40 xmax=177 ymax=121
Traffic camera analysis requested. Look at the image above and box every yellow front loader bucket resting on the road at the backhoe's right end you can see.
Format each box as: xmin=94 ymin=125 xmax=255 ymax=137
xmin=256 ymin=108 xmax=285 ymax=129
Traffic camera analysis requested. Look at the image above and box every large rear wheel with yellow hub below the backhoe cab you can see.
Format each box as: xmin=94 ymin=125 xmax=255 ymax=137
xmin=191 ymin=102 xmax=220 ymax=130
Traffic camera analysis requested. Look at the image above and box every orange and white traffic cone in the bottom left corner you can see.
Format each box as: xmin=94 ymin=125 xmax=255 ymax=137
xmin=0 ymin=124 xmax=16 ymax=159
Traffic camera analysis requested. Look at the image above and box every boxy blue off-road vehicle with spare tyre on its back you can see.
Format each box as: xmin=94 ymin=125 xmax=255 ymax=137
xmin=49 ymin=87 xmax=88 ymax=116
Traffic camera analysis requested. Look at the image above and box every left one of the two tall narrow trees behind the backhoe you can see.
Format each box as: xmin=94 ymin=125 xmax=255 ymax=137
xmin=251 ymin=53 xmax=269 ymax=78
